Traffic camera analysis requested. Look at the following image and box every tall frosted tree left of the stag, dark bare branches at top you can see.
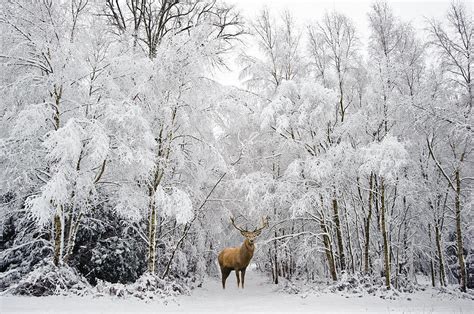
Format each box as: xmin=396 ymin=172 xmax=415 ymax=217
xmin=101 ymin=1 xmax=242 ymax=273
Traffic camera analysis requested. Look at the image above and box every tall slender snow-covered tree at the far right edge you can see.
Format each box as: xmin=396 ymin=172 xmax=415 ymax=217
xmin=426 ymin=2 xmax=474 ymax=291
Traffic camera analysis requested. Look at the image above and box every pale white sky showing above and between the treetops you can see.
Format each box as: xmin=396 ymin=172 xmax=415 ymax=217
xmin=215 ymin=0 xmax=466 ymax=85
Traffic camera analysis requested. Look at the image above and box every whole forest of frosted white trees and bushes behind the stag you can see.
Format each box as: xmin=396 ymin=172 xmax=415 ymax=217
xmin=0 ymin=0 xmax=474 ymax=310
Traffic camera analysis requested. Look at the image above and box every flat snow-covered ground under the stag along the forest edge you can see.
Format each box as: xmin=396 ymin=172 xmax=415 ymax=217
xmin=0 ymin=271 xmax=474 ymax=314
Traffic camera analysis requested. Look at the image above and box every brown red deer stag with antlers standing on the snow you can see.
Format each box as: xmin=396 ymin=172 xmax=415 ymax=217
xmin=218 ymin=217 xmax=268 ymax=289
